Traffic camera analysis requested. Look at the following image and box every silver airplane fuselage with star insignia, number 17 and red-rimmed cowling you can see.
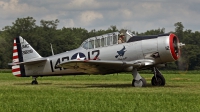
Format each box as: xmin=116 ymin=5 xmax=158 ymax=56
xmin=24 ymin=34 xmax=180 ymax=76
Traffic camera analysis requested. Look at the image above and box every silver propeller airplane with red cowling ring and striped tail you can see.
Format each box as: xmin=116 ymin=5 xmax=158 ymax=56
xmin=9 ymin=31 xmax=184 ymax=87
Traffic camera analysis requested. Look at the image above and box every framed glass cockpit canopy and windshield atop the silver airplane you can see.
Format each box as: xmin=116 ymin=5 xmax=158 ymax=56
xmin=81 ymin=31 xmax=134 ymax=49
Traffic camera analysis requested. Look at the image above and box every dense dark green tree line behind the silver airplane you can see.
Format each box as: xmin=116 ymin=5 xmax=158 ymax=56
xmin=0 ymin=17 xmax=200 ymax=70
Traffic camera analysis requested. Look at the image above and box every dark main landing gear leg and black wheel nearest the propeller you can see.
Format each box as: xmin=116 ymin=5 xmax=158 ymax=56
xmin=151 ymin=67 xmax=165 ymax=86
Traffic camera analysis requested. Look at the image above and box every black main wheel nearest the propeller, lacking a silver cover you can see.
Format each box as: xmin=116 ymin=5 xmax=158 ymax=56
xmin=151 ymin=75 xmax=165 ymax=86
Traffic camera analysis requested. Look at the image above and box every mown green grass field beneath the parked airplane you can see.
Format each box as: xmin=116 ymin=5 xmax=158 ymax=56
xmin=0 ymin=73 xmax=200 ymax=112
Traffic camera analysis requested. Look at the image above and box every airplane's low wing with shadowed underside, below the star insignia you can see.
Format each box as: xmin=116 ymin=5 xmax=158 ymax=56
xmin=57 ymin=59 xmax=154 ymax=74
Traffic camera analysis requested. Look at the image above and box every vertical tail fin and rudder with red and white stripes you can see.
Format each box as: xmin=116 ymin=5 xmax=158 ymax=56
xmin=12 ymin=36 xmax=41 ymax=77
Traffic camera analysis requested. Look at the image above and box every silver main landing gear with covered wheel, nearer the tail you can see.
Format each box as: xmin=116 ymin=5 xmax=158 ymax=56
xmin=132 ymin=69 xmax=146 ymax=87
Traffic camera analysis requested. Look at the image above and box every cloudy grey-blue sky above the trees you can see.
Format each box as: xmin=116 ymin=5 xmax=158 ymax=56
xmin=0 ymin=0 xmax=200 ymax=33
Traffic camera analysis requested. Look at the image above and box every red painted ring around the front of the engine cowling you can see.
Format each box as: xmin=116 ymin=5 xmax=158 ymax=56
xmin=169 ymin=33 xmax=180 ymax=60
